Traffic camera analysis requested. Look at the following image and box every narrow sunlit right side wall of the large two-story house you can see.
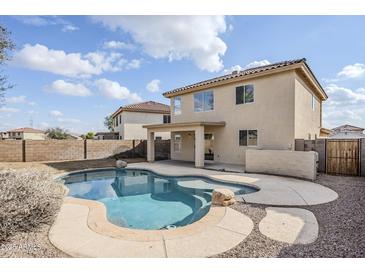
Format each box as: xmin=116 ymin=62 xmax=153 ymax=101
xmin=295 ymin=75 xmax=322 ymax=140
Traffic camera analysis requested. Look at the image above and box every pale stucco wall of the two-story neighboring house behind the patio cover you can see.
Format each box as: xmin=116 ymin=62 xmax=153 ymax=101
xmin=114 ymin=111 xmax=170 ymax=140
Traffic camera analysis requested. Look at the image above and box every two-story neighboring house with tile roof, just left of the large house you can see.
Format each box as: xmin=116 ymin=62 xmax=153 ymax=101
xmin=112 ymin=101 xmax=170 ymax=140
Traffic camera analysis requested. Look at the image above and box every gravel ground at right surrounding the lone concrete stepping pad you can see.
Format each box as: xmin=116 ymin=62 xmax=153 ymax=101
xmin=217 ymin=175 xmax=365 ymax=258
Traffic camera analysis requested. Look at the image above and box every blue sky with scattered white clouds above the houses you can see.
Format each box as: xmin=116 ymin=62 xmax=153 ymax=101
xmin=0 ymin=16 xmax=365 ymax=133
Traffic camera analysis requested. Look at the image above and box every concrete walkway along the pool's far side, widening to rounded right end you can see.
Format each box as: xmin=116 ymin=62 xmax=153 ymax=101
xmin=128 ymin=161 xmax=338 ymax=206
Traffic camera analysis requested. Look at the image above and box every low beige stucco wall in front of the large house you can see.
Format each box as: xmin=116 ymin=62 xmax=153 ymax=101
xmin=246 ymin=150 xmax=317 ymax=180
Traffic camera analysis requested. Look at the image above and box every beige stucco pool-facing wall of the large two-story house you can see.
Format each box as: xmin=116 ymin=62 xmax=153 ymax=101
xmin=171 ymin=71 xmax=295 ymax=164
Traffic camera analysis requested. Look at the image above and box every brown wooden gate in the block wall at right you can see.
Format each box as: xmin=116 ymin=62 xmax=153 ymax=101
xmin=326 ymin=139 xmax=360 ymax=176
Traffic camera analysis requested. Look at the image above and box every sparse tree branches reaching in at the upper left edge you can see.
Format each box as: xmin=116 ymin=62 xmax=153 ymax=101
xmin=0 ymin=26 xmax=15 ymax=104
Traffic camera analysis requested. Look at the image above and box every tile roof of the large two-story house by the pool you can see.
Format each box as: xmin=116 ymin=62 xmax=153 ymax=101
xmin=163 ymin=58 xmax=314 ymax=97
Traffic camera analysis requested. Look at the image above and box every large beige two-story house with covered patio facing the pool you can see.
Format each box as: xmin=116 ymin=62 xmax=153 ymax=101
xmin=144 ymin=59 xmax=327 ymax=167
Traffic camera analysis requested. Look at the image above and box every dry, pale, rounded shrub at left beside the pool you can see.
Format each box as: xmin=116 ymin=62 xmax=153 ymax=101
xmin=0 ymin=170 xmax=63 ymax=242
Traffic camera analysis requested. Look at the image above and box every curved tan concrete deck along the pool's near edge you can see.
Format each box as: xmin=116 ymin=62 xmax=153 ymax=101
xmin=49 ymin=198 xmax=253 ymax=258
